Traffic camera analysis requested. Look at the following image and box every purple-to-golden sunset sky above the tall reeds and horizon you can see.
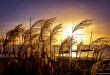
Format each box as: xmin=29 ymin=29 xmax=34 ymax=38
xmin=0 ymin=0 xmax=110 ymax=43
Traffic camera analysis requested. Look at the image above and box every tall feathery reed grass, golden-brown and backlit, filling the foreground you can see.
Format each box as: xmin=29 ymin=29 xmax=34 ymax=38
xmin=0 ymin=18 xmax=110 ymax=75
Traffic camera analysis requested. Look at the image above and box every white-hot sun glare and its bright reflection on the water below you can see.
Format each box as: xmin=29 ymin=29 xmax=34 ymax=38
xmin=62 ymin=24 xmax=84 ymax=57
